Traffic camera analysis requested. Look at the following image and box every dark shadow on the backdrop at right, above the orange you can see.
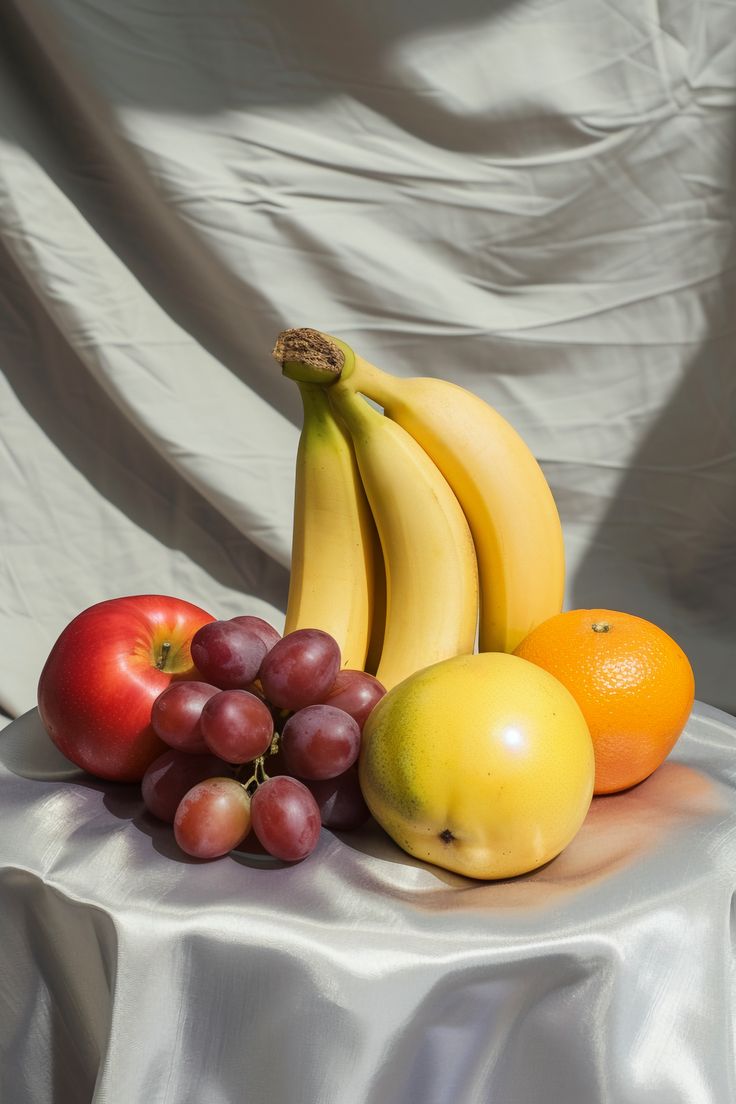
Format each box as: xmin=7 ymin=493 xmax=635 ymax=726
xmin=573 ymin=112 xmax=736 ymax=713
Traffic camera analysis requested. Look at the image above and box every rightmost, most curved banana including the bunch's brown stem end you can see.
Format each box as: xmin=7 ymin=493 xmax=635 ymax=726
xmin=275 ymin=329 xmax=565 ymax=651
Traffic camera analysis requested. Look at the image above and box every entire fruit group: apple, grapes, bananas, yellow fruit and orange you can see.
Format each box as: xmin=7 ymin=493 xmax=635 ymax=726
xmin=39 ymin=329 xmax=695 ymax=879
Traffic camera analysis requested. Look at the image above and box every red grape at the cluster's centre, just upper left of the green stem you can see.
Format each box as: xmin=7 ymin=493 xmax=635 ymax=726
xmin=201 ymin=690 xmax=274 ymax=763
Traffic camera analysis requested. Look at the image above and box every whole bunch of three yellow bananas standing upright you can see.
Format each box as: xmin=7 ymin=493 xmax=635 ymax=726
xmin=274 ymin=329 xmax=565 ymax=689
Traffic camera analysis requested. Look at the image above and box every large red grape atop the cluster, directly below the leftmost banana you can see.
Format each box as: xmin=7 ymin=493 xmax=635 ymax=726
xmin=259 ymin=625 xmax=340 ymax=709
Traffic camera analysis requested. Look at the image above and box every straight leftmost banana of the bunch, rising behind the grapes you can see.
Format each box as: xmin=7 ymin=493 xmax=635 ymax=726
xmin=284 ymin=382 xmax=381 ymax=670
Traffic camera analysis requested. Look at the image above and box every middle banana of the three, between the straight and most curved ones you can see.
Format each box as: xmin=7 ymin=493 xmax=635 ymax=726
xmin=327 ymin=383 xmax=478 ymax=690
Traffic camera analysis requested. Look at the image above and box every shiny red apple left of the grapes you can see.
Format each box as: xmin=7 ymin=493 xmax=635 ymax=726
xmin=39 ymin=594 xmax=214 ymax=782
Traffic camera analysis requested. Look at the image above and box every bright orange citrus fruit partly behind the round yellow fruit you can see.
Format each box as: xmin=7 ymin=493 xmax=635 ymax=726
xmin=514 ymin=609 xmax=695 ymax=794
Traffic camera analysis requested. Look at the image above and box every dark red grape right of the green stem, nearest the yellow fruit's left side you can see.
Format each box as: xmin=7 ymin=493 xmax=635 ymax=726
xmin=280 ymin=705 xmax=361 ymax=778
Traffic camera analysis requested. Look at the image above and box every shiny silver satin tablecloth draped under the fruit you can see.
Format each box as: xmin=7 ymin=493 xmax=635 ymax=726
xmin=0 ymin=702 xmax=736 ymax=1104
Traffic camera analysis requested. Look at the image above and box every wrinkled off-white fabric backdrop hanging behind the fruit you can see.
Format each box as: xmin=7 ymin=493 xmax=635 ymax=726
xmin=0 ymin=0 xmax=736 ymax=720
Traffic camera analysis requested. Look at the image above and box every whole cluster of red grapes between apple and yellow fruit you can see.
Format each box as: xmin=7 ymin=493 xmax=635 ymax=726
xmin=141 ymin=616 xmax=385 ymax=862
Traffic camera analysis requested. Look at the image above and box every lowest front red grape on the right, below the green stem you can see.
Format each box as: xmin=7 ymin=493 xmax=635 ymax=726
xmin=250 ymin=774 xmax=321 ymax=862
